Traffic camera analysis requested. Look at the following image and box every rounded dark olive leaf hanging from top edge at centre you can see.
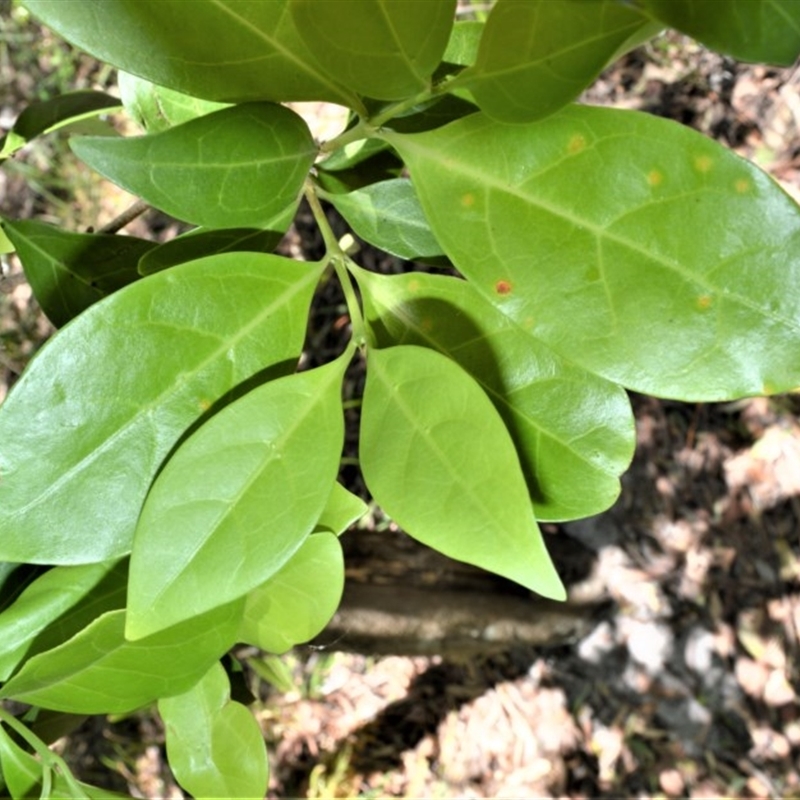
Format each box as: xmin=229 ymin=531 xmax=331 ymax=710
xmin=289 ymin=0 xmax=456 ymax=100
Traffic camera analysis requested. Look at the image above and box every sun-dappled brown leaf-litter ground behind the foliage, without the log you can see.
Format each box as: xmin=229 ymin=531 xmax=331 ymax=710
xmin=0 ymin=8 xmax=800 ymax=798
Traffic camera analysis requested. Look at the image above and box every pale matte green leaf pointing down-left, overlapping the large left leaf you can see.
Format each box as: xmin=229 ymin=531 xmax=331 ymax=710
xmin=126 ymin=352 xmax=350 ymax=639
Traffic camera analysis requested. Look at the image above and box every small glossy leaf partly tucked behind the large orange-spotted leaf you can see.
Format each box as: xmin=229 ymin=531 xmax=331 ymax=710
xmin=323 ymin=178 xmax=443 ymax=259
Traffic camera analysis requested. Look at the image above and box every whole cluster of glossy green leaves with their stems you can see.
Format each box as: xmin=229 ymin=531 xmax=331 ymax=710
xmin=0 ymin=0 xmax=800 ymax=797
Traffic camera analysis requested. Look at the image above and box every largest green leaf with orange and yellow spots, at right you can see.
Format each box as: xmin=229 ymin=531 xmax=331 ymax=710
xmin=387 ymin=106 xmax=800 ymax=400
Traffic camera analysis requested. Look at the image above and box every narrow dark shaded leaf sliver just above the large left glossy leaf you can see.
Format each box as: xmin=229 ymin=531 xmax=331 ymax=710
xmin=138 ymin=228 xmax=283 ymax=275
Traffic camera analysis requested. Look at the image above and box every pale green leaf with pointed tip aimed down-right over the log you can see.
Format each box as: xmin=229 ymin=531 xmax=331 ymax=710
xmin=360 ymin=346 xmax=566 ymax=599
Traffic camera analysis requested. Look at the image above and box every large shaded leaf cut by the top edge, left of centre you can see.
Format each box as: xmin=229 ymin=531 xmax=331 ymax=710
xmin=24 ymin=0 xmax=360 ymax=108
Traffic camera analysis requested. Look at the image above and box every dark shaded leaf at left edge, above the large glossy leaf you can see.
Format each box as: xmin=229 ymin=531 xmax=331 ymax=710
xmin=2 ymin=220 xmax=157 ymax=327
